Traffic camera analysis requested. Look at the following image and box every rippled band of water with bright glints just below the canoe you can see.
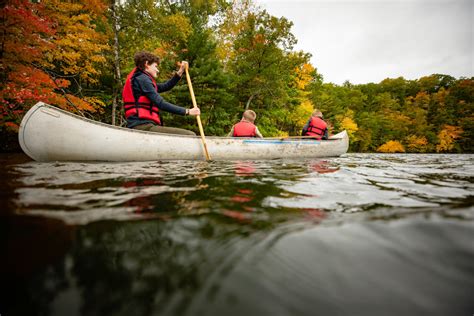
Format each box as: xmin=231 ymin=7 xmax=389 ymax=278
xmin=13 ymin=154 xmax=474 ymax=224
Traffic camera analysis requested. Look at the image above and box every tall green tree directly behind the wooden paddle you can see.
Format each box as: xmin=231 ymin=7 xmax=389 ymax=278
xmin=157 ymin=0 xmax=237 ymax=135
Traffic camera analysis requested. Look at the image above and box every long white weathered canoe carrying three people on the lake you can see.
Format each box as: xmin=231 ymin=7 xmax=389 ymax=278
xmin=18 ymin=102 xmax=349 ymax=161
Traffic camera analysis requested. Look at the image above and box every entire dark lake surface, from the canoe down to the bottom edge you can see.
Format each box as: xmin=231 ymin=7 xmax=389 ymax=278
xmin=0 ymin=154 xmax=474 ymax=316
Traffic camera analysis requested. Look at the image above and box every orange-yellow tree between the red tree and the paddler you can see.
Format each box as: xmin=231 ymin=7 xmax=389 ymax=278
xmin=40 ymin=0 xmax=109 ymax=112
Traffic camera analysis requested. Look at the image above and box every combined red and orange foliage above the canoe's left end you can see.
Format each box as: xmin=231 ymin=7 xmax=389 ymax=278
xmin=0 ymin=0 xmax=107 ymax=130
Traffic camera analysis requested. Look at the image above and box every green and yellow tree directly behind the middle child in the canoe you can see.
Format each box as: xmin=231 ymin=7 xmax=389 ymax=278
xmin=225 ymin=11 xmax=294 ymax=134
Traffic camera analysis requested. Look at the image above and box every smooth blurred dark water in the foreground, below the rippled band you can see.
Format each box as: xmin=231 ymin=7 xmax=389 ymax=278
xmin=3 ymin=210 xmax=474 ymax=315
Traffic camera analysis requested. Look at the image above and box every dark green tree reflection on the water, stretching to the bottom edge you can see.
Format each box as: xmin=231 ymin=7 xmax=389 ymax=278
xmin=3 ymin=160 xmax=318 ymax=315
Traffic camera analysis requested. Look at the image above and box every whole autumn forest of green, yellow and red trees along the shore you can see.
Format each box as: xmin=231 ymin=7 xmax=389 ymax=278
xmin=0 ymin=0 xmax=474 ymax=153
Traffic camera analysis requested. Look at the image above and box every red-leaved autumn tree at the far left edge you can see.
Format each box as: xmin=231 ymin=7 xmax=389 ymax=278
xmin=0 ymin=0 xmax=57 ymax=134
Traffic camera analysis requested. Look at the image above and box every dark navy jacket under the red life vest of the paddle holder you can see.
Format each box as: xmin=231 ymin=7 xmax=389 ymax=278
xmin=127 ymin=69 xmax=186 ymax=128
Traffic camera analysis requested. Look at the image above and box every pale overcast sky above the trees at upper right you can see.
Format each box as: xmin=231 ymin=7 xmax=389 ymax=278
xmin=255 ymin=0 xmax=474 ymax=84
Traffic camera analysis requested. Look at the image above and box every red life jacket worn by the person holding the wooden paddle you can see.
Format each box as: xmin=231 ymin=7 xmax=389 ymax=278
xmin=122 ymin=68 xmax=162 ymax=125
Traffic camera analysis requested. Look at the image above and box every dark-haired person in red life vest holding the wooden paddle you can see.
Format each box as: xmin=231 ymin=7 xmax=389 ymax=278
xmin=122 ymin=51 xmax=201 ymax=135
